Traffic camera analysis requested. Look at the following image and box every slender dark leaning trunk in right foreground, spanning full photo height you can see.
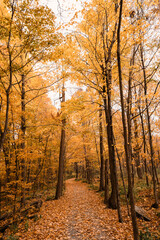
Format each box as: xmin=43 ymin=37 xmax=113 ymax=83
xmin=117 ymin=0 xmax=139 ymax=237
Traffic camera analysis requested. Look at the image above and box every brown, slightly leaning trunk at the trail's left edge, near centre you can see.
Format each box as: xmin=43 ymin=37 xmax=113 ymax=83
xmin=55 ymin=86 xmax=66 ymax=199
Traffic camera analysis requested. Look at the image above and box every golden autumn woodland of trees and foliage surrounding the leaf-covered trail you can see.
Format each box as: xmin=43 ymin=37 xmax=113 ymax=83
xmin=0 ymin=0 xmax=160 ymax=240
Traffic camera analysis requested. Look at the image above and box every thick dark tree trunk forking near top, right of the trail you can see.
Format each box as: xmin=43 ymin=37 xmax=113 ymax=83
xmin=101 ymin=7 xmax=120 ymax=209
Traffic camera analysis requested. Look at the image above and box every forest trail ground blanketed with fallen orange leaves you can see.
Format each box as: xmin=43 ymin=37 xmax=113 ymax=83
xmin=18 ymin=179 xmax=132 ymax=240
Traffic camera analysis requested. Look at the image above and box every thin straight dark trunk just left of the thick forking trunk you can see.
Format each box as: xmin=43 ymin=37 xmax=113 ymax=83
xmin=99 ymin=107 xmax=104 ymax=191
